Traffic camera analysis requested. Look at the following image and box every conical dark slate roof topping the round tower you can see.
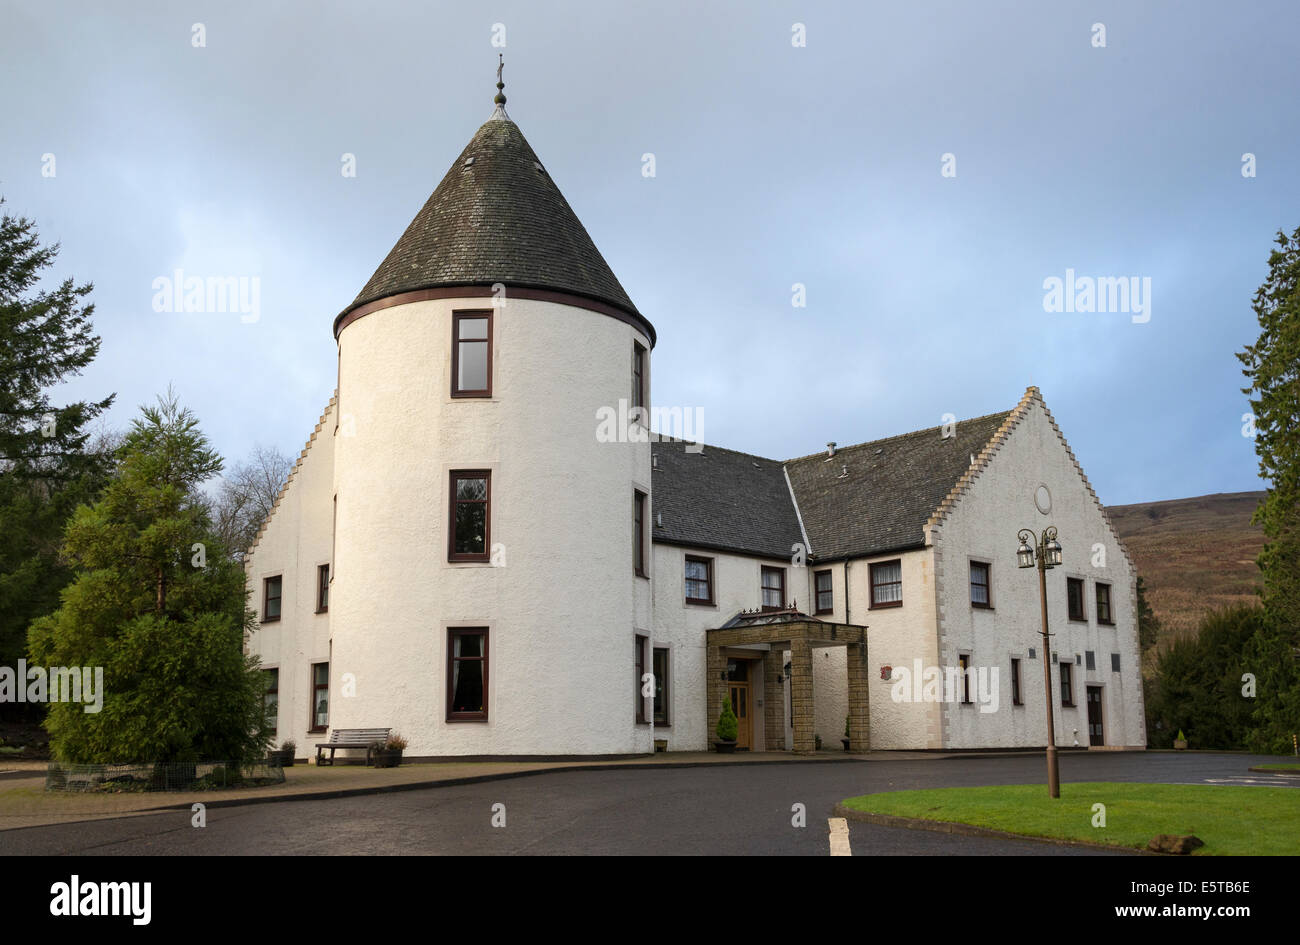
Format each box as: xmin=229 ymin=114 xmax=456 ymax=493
xmin=335 ymin=105 xmax=654 ymax=343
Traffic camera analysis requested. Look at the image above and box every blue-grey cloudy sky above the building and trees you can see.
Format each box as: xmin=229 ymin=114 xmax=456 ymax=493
xmin=0 ymin=0 xmax=1300 ymax=504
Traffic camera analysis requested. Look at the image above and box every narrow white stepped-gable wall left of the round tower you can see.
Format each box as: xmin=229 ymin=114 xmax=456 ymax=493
xmin=244 ymin=400 xmax=334 ymax=758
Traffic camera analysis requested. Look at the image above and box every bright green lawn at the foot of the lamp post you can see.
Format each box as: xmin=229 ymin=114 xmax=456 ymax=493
xmin=844 ymin=781 xmax=1300 ymax=855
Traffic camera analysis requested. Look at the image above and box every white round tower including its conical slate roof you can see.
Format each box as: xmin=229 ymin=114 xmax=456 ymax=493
xmin=329 ymin=77 xmax=655 ymax=757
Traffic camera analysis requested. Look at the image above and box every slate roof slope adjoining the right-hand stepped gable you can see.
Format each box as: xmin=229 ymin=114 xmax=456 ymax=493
xmin=787 ymin=411 xmax=1010 ymax=560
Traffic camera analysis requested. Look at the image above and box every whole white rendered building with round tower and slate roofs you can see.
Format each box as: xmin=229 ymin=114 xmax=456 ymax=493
xmin=244 ymin=79 xmax=1145 ymax=758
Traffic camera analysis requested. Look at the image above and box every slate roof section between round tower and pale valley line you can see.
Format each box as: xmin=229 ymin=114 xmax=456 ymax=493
xmin=650 ymin=439 xmax=803 ymax=558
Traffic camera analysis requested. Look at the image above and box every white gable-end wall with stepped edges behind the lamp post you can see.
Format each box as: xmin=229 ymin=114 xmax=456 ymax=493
xmin=932 ymin=400 xmax=1145 ymax=749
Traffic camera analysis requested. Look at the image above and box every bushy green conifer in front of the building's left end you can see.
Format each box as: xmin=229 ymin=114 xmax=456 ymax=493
xmin=30 ymin=393 xmax=267 ymax=763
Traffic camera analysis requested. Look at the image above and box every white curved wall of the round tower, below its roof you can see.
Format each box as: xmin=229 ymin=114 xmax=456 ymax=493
xmin=332 ymin=299 xmax=654 ymax=757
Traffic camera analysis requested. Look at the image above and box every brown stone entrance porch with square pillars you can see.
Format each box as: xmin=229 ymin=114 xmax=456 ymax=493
xmin=705 ymin=604 xmax=871 ymax=754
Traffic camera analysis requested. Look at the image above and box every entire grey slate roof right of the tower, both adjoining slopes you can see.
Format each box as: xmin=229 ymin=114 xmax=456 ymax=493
xmin=651 ymin=411 xmax=1010 ymax=562
